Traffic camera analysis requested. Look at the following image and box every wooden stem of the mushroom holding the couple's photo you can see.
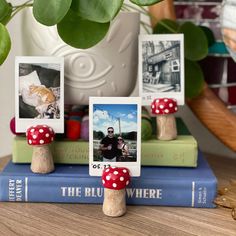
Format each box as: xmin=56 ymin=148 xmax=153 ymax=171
xmin=102 ymin=188 xmax=126 ymax=217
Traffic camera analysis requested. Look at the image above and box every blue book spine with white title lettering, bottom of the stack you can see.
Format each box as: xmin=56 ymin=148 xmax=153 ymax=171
xmin=0 ymin=175 xmax=216 ymax=208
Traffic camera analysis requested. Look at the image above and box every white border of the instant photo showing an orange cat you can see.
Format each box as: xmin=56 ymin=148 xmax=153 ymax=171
xmin=15 ymin=56 xmax=64 ymax=133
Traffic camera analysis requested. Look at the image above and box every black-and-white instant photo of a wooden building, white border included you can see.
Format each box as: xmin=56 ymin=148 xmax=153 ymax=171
xmin=139 ymin=34 xmax=185 ymax=106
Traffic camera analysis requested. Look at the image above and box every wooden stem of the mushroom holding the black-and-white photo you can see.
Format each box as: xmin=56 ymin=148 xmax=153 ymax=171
xmin=156 ymin=114 xmax=177 ymax=140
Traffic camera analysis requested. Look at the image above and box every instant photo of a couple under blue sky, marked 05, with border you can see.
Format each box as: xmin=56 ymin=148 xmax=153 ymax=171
xmin=89 ymin=97 xmax=141 ymax=176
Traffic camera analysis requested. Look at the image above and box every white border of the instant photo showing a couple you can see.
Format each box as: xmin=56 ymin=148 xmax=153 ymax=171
xmin=89 ymin=97 xmax=141 ymax=176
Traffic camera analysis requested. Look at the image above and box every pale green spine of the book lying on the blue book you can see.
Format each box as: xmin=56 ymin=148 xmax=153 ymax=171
xmin=12 ymin=135 xmax=198 ymax=167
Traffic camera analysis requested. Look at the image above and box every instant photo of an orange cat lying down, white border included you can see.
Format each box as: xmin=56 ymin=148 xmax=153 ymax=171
xmin=15 ymin=57 xmax=64 ymax=133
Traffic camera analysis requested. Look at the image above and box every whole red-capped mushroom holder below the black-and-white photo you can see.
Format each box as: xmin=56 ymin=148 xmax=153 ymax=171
xmin=151 ymin=98 xmax=178 ymax=140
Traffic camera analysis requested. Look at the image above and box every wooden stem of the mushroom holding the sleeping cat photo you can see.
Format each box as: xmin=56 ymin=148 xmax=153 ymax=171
xmin=31 ymin=145 xmax=54 ymax=174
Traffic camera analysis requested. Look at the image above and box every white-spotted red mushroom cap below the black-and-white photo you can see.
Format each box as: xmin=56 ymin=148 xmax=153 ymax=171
xmin=151 ymin=98 xmax=178 ymax=115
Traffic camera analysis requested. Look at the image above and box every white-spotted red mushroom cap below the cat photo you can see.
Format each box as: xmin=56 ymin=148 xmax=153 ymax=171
xmin=26 ymin=125 xmax=55 ymax=145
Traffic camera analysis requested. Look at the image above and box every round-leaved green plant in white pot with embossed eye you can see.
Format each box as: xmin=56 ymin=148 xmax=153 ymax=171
xmin=0 ymin=0 xmax=208 ymax=104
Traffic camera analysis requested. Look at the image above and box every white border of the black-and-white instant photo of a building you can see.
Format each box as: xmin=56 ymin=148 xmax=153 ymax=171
xmin=138 ymin=34 xmax=185 ymax=106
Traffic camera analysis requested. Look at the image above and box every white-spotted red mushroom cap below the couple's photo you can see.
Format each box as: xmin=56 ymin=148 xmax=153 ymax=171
xmin=102 ymin=167 xmax=130 ymax=190
